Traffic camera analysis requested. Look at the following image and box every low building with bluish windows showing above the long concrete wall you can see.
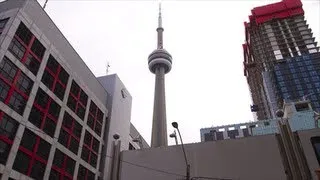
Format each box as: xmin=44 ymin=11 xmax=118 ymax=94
xmin=200 ymin=101 xmax=319 ymax=142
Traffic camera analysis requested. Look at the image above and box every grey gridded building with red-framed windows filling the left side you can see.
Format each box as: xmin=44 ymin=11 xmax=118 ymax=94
xmin=0 ymin=0 xmax=147 ymax=180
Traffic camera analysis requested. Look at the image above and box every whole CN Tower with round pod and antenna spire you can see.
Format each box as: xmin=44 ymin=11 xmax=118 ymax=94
xmin=148 ymin=4 xmax=172 ymax=147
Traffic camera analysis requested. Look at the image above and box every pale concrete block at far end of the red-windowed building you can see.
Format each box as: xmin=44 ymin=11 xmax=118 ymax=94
xmin=97 ymin=74 xmax=132 ymax=179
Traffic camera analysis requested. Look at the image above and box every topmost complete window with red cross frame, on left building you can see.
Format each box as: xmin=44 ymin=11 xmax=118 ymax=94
xmin=8 ymin=22 xmax=45 ymax=75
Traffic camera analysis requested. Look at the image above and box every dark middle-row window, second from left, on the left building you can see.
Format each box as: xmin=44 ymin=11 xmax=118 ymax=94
xmin=29 ymin=88 xmax=61 ymax=137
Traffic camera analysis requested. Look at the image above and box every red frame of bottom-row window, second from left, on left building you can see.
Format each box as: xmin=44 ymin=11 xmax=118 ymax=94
xmin=13 ymin=128 xmax=51 ymax=177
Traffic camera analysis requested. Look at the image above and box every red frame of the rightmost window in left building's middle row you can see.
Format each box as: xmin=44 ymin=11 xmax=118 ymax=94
xmin=81 ymin=131 xmax=100 ymax=168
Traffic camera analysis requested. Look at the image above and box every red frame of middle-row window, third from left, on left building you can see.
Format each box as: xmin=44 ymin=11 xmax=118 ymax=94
xmin=58 ymin=111 xmax=82 ymax=155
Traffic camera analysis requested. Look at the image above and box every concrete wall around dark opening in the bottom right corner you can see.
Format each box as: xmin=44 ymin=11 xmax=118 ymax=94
xmin=298 ymin=128 xmax=320 ymax=180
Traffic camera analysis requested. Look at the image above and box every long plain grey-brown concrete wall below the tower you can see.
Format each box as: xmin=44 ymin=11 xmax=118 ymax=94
xmin=120 ymin=135 xmax=286 ymax=180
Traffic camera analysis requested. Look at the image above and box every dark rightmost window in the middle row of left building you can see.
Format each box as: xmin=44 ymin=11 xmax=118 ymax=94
xmin=81 ymin=131 xmax=100 ymax=168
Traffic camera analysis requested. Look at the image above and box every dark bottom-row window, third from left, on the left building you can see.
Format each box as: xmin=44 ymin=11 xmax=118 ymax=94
xmin=49 ymin=149 xmax=76 ymax=180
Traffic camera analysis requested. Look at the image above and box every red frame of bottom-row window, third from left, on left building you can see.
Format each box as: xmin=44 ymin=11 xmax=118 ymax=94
xmin=50 ymin=149 xmax=76 ymax=180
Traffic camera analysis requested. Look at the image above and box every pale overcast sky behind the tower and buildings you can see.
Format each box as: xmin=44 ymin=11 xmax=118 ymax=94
xmin=38 ymin=0 xmax=320 ymax=144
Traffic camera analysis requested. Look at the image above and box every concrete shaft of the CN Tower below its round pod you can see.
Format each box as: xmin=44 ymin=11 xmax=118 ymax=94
xmin=151 ymin=66 xmax=168 ymax=147
